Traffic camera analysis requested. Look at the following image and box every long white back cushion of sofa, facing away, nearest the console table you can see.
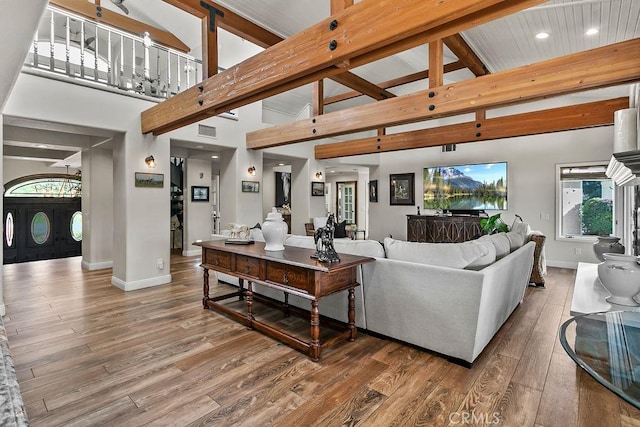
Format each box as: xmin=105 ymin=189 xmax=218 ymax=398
xmin=384 ymin=237 xmax=489 ymax=268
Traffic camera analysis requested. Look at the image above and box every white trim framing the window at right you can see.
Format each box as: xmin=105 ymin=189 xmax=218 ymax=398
xmin=555 ymin=160 xmax=625 ymax=243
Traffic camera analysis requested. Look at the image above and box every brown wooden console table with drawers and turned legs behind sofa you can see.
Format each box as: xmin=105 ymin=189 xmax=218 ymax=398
xmin=194 ymin=240 xmax=374 ymax=361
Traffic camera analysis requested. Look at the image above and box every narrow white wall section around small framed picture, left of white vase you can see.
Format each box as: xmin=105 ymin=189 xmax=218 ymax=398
xmin=182 ymin=159 xmax=213 ymax=256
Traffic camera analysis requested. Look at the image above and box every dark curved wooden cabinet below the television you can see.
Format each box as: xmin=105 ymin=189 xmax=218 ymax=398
xmin=407 ymin=215 xmax=484 ymax=243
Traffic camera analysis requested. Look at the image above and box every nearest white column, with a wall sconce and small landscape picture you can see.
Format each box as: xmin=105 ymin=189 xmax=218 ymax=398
xmin=111 ymin=129 xmax=171 ymax=291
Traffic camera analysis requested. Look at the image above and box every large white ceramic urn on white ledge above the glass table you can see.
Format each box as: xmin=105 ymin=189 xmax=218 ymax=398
xmin=598 ymin=253 xmax=640 ymax=307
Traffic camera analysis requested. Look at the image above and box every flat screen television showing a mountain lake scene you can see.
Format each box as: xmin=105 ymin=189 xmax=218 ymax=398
xmin=422 ymin=162 xmax=507 ymax=213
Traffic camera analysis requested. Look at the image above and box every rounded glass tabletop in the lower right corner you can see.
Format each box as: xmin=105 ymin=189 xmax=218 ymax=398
xmin=560 ymin=311 xmax=640 ymax=409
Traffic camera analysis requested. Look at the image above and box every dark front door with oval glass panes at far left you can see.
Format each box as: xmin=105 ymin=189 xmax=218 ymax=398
xmin=3 ymin=197 xmax=82 ymax=264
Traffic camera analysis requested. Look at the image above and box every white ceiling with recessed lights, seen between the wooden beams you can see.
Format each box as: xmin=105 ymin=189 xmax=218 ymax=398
xmin=0 ymin=0 xmax=640 ymax=170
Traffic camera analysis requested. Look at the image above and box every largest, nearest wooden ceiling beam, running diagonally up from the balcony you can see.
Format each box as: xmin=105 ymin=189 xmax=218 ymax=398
xmin=141 ymin=0 xmax=544 ymax=134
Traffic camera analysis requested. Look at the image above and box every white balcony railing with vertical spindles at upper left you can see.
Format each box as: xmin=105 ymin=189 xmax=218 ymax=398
xmin=25 ymin=6 xmax=202 ymax=98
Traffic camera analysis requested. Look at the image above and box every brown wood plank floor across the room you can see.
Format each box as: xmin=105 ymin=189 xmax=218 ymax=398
xmin=3 ymin=256 xmax=640 ymax=427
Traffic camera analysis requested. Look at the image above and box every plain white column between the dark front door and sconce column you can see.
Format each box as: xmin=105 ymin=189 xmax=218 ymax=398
xmin=81 ymin=148 xmax=114 ymax=270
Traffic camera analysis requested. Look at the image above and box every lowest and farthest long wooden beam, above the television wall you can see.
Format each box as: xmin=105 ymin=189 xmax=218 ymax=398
xmin=315 ymin=97 xmax=629 ymax=159
